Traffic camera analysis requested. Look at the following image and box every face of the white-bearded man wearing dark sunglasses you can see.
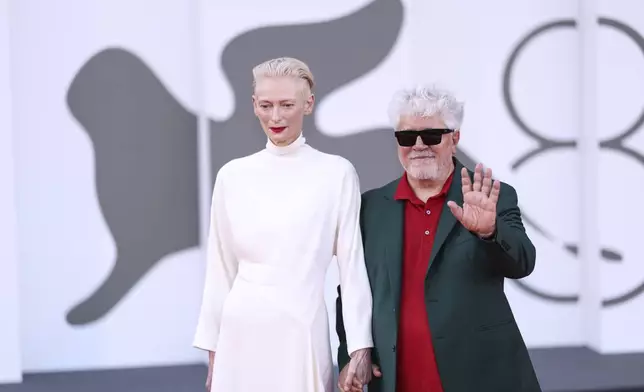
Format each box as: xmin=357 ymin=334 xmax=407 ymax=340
xmin=397 ymin=116 xmax=460 ymax=180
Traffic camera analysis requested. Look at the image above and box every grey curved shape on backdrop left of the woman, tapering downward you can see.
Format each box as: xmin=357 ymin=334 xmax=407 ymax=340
xmin=67 ymin=49 xmax=199 ymax=325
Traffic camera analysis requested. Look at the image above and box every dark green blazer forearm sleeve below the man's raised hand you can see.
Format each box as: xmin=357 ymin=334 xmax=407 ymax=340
xmin=485 ymin=184 xmax=536 ymax=279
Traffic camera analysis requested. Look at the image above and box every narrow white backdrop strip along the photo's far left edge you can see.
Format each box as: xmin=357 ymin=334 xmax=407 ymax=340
xmin=0 ymin=0 xmax=22 ymax=383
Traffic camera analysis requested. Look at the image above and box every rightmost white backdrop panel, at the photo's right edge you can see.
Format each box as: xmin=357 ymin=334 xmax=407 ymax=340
xmin=594 ymin=0 xmax=644 ymax=352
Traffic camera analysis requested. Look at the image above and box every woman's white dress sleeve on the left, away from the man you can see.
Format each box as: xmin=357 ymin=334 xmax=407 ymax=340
xmin=193 ymin=170 xmax=237 ymax=351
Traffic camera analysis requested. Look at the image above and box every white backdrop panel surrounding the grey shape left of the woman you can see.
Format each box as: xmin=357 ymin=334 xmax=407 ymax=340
xmin=11 ymin=0 xmax=202 ymax=371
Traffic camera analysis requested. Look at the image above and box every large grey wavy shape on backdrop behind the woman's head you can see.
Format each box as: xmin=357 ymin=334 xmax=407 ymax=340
xmin=211 ymin=0 xmax=404 ymax=189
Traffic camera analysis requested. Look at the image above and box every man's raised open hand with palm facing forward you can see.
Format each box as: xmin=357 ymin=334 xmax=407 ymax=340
xmin=447 ymin=163 xmax=501 ymax=237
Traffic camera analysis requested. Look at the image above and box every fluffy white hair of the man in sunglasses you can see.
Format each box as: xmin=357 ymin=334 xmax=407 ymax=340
xmin=389 ymin=86 xmax=464 ymax=129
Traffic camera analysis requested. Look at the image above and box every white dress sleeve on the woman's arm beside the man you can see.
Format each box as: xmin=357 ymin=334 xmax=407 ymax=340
xmin=335 ymin=164 xmax=373 ymax=355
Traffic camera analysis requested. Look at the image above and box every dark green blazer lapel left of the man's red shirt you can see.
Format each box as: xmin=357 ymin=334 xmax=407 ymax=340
xmin=380 ymin=179 xmax=405 ymax=306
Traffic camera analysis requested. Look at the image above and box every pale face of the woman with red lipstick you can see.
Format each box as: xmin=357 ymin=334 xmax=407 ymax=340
xmin=253 ymin=77 xmax=314 ymax=146
